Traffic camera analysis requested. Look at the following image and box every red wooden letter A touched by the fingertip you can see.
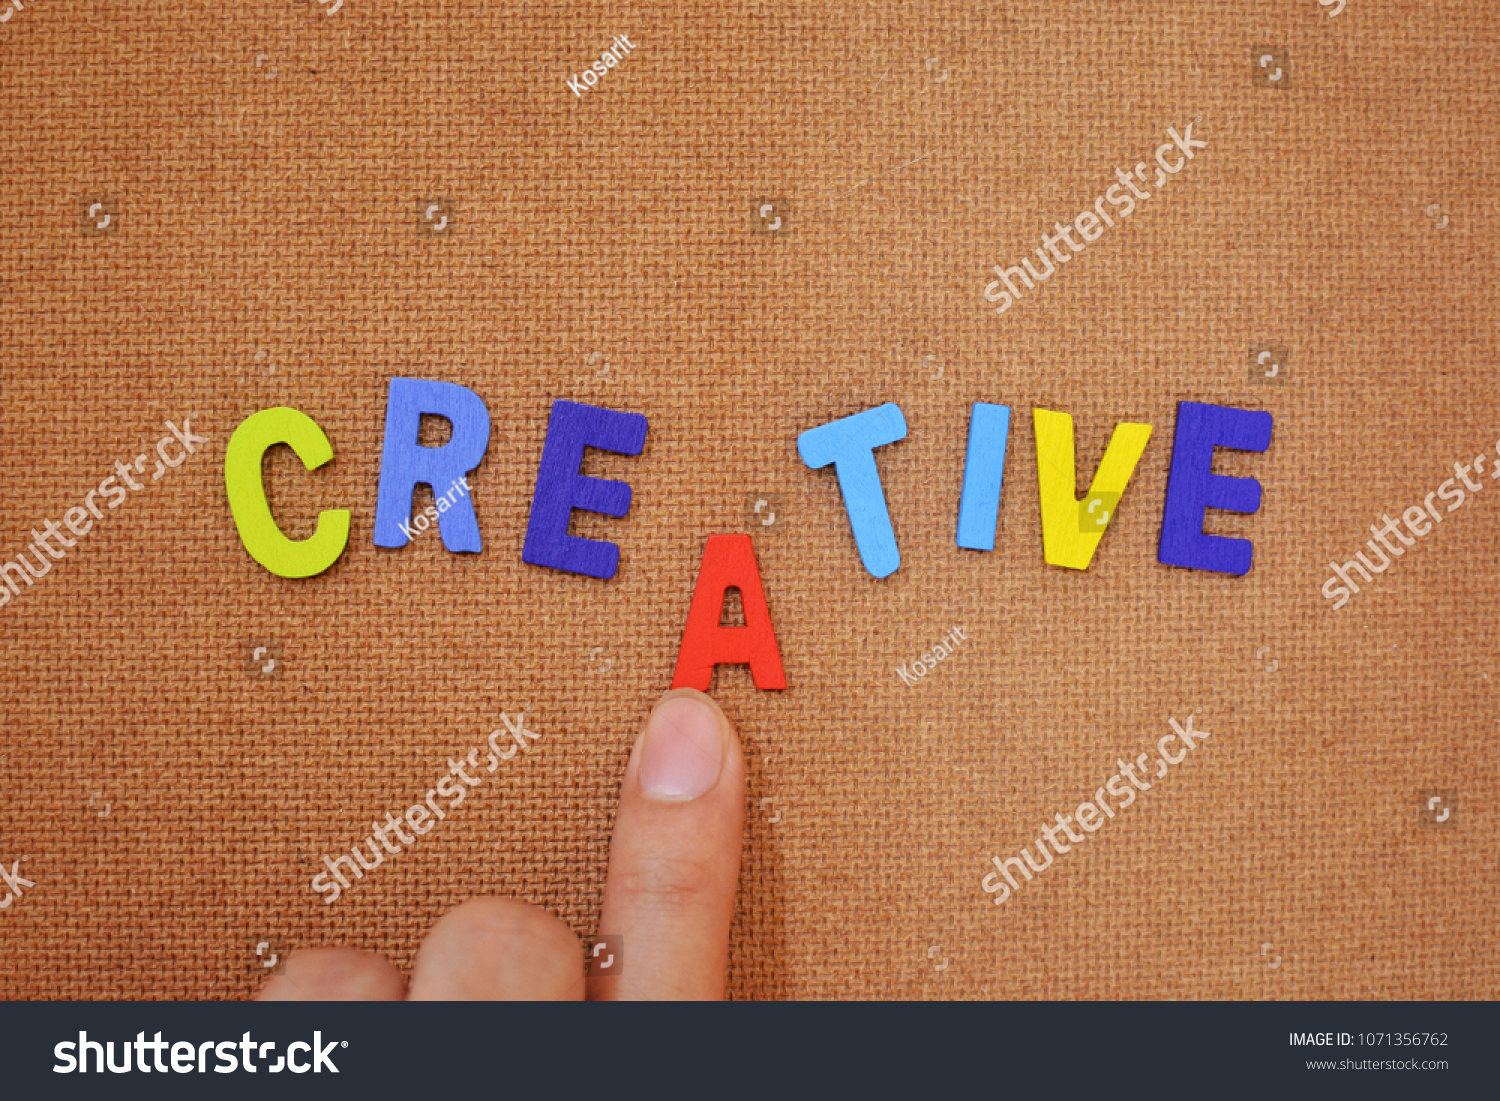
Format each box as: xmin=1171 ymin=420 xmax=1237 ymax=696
xmin=672 ymin=536 xmax=786 ymax=692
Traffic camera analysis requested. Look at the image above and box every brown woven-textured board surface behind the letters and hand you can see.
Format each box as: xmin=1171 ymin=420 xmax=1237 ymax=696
xmin=0 ymin=0 xmax=1500 ymax=999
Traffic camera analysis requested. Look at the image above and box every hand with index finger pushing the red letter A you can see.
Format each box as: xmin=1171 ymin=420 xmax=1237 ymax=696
xmin=260 ymin=689 xmax=746 ymax=1001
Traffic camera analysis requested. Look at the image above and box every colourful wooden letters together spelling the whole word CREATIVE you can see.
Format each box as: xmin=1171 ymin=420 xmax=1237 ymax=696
xmin=224 ymin=378 xmax=1272 ymax=692
